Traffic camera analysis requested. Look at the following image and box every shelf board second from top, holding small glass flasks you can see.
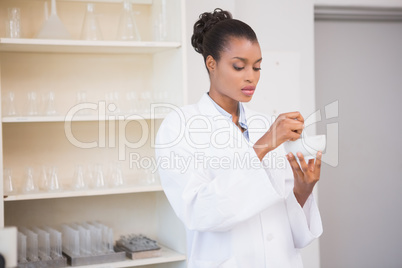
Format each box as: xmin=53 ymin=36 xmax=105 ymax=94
xmin=2 ymin=114 xmax=165 ymax=123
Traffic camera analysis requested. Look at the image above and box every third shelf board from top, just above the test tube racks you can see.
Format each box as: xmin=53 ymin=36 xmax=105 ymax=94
xmin=4 ymin=184 xmax=163 ymax=201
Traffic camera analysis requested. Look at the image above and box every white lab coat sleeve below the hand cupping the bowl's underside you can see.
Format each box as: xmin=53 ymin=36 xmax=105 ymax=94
xmin=285 ymin=163 xmax=322 ymax=248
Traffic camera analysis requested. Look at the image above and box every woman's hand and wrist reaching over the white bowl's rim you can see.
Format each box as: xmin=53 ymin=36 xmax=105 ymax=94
xmin=254 ymin=112 xmax=304 ymax=160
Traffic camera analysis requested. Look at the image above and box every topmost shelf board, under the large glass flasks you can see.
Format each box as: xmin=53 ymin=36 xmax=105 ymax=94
xmin=0 ymin=38 xmax=181 ymax=54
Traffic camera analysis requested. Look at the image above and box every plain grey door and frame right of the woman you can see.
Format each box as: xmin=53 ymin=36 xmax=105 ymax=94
xmin=315 ymin=6 xmax=402 ymax=268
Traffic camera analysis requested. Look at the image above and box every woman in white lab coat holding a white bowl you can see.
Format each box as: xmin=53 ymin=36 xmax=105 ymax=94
xmin=156 ymin=9 xmax=322 ymax=268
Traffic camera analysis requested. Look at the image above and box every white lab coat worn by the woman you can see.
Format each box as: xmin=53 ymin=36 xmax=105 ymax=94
xmin=156 ymin=94 xmax=322 ymax=268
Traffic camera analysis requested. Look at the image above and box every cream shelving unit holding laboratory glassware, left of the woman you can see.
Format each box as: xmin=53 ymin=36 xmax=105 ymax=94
xmin=0 ymin=0 xmax=186 ymax=268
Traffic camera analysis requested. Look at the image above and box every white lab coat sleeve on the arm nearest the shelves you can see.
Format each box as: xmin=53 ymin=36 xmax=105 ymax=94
xmin=155 ymin=111 xmax=282 ymax=232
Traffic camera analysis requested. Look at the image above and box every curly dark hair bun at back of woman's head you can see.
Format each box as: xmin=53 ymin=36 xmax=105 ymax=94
xmin=191 ymin=8 xmax=232 ymax=54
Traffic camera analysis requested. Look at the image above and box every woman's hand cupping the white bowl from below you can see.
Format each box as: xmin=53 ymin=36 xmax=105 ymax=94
xmin=286 ymin=152 xmax=322 ymax=207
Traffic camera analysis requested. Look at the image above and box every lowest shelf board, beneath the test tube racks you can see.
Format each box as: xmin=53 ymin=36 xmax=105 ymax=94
xmin=75 ymin=246 xmax=186 ymax=268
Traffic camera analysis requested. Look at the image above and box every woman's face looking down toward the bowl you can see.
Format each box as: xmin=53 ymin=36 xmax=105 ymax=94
xmin=207 ymin=38 xmax=262 ymax=104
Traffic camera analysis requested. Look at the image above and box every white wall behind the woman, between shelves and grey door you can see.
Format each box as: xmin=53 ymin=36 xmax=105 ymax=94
xmin=186 ymin=0 xmax=319 ymax=268
